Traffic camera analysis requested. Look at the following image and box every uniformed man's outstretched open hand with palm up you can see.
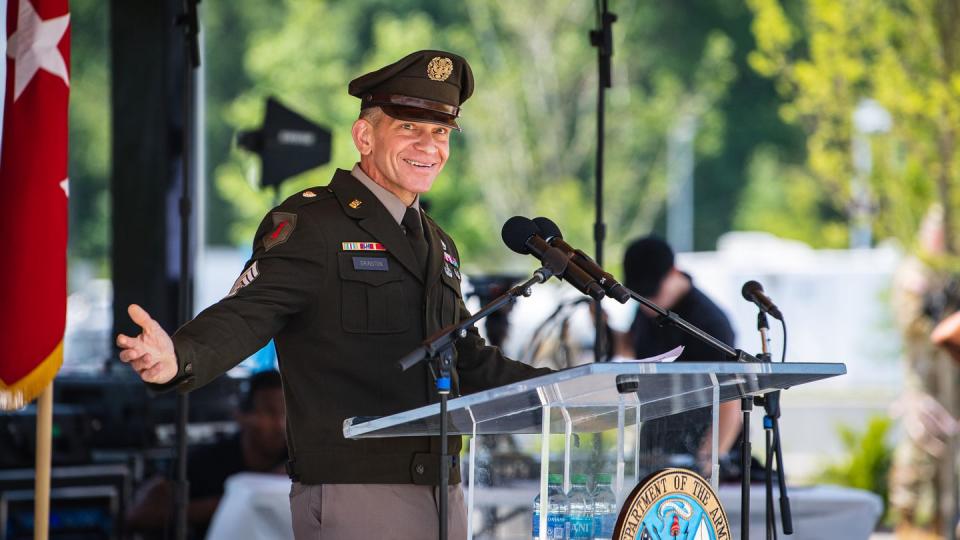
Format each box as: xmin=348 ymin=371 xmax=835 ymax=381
xmin=117 ymin=304 xmax=180 ymax=384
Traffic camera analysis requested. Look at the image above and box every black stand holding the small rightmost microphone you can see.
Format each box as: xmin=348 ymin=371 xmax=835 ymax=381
xmin=755 ymin=311 xmax=793 ymax=540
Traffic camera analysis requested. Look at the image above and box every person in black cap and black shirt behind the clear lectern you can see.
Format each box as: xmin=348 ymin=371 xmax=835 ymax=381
xmin=615 ymin=236 xmax=742 ymax=479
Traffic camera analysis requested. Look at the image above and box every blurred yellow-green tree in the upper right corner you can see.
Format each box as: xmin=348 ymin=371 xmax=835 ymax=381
xmin=748 ymin=0 xmax=960 ymax=254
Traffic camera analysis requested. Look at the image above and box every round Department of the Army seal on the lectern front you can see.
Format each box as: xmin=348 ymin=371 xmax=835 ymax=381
xmin=613 ymin=469 xmax=731 ymax=540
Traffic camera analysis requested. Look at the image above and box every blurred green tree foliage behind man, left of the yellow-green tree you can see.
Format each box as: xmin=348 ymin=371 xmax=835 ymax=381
xmin=70 ymin=0 xmax=795 ymax=272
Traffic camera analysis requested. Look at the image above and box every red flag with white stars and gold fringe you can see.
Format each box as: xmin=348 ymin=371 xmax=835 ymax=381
xmin=0 ymin=0 xmax=70 ymax=409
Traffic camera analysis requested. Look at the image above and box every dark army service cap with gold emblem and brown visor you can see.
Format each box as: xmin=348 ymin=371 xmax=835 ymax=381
xmin=349 ymin=50 xmax=473 ymax=131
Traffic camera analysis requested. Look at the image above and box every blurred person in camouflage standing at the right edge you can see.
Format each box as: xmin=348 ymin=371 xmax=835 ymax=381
xmin=889 ymin=206 xmax=960 ymax=539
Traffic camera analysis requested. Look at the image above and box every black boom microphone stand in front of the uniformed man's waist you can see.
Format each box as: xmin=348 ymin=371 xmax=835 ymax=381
xmin=397 ymin=257 xmax=567 ymax=540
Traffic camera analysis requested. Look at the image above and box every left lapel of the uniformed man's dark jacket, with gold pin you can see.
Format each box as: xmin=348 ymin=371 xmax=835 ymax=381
xmin=330 ymin=169 xmax=423 ymax=282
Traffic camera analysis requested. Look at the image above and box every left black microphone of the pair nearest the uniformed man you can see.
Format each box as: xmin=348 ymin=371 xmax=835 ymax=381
xmin=500 ymin=216 xmax=604 ymax=300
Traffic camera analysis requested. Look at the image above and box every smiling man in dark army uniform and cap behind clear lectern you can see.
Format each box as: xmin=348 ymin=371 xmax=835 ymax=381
xmin=117 ymin=51 xmax=548 ymax=540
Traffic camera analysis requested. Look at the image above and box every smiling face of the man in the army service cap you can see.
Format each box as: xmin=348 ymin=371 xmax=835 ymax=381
xmin=353 ymin=110 xmax=450 ymax=205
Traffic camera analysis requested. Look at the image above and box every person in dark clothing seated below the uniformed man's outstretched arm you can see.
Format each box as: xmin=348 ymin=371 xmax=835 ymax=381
xmin=126 ymin=370 xmax=287 ymax=538
